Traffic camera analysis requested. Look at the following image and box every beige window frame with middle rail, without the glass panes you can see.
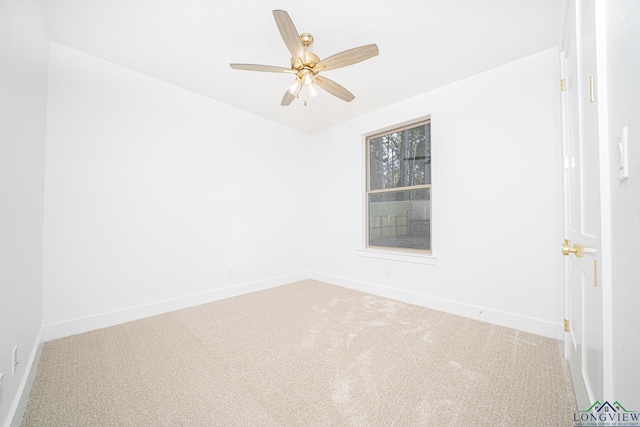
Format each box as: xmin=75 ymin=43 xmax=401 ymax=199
xmin=364 ymin=116 xmax=433 ymax=257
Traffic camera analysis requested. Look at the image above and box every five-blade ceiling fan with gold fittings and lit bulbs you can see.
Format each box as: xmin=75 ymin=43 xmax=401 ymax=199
xmin=230 ymin=10 xmax=378 ymax=106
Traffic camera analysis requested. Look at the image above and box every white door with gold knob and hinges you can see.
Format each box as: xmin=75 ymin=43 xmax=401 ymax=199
xmin=559 ymin=0 xmax=604 ymax=410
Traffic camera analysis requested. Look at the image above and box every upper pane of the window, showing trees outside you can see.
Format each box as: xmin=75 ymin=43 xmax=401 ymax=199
xmin=369 ymin=123 xmax=431 ymax=190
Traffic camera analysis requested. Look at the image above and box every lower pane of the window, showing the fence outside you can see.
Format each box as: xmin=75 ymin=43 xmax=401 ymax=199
xmin=369 ymin=188 xmax=431 ymax=250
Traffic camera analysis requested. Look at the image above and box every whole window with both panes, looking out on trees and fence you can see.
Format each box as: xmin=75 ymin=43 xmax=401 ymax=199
xmin=366 ymin=120 xmax=431 ymax=253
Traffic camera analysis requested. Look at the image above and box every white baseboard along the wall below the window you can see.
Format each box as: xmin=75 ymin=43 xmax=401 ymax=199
xmin=309 ymin=272 xmax=564 ymax=340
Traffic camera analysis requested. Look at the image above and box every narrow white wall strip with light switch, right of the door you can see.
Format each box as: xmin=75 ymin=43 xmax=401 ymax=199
xmin=604 ymin=0 xmax=640 ymax=411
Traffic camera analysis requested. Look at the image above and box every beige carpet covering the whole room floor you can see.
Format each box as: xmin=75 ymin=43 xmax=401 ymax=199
xmin=22 ymin=280 xmax=576 ymax=427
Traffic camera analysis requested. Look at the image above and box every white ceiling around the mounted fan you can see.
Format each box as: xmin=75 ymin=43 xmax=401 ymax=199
xmin=47 ymin=0 xmax=562 ymax=133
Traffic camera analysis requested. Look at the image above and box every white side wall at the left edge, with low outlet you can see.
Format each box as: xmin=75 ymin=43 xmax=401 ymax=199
xmin=0 ymin=0 xmax=49 ymax=425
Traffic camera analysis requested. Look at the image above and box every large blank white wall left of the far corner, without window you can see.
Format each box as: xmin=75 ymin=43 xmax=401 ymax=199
xmin=44 ymin=43 xmax=309 ymax=340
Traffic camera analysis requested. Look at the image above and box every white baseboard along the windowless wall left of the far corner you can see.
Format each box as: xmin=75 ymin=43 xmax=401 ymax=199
xmin=43 ymin=272 xmax=309 ymax=342
